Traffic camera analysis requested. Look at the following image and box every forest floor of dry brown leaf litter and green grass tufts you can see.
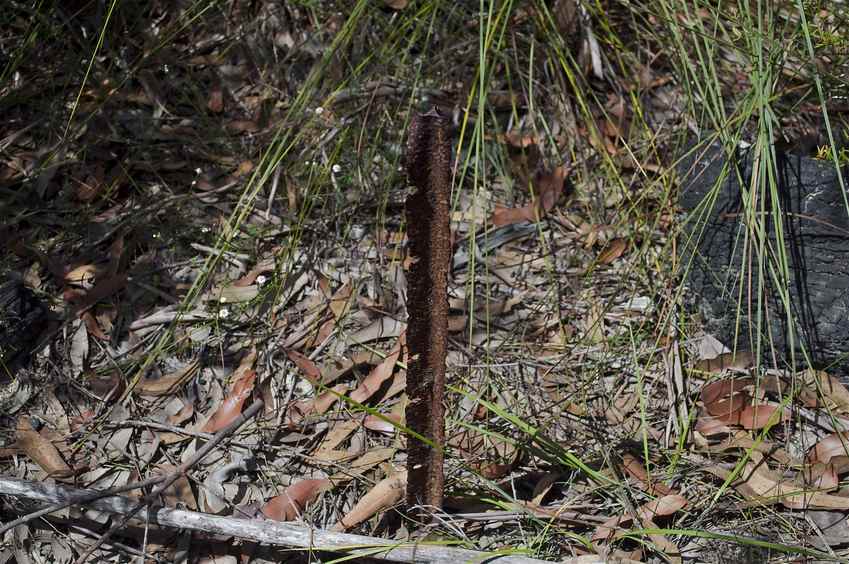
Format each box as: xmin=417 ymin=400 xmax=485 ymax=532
xmin=0 ymin=0 xmax=849 ymax=563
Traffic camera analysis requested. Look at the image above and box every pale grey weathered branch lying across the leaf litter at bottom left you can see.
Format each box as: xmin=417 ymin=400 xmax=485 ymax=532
xmin=0 ymin=478 xmax=584 ymax=564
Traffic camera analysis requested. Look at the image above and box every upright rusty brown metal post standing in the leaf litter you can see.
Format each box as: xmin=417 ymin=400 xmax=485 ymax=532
xmin=406 ymin=110 xmax=451 ymax=508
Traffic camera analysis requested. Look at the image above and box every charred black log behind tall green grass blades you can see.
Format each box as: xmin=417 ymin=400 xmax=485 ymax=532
xmin=679 ymin=140 xmax=849 ymax=368
